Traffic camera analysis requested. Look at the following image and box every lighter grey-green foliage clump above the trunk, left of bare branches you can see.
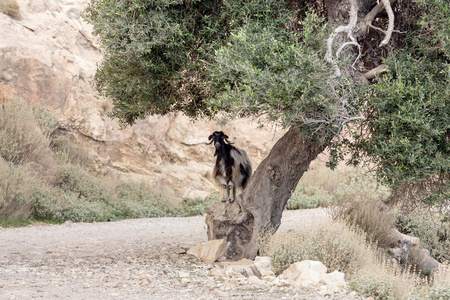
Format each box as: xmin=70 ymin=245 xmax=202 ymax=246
xmin=208 ymin=13 xmax=359 ymax=143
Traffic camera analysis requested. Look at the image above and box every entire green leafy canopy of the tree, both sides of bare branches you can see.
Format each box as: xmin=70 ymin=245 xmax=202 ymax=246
xmin=85 ymin=0 xmax=450 ymax=205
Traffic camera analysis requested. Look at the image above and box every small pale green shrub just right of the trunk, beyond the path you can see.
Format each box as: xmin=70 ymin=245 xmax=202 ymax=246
xmin=286 ymin=184 xmax=332 ymax=209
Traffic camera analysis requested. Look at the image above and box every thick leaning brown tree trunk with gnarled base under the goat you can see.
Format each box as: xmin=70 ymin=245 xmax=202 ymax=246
xmin=206 ymin=128 xmax=325 ymax=260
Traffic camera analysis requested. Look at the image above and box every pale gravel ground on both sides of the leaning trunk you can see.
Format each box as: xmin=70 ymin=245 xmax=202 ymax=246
xmin=0 ymin=209 xmax=360 ymax=299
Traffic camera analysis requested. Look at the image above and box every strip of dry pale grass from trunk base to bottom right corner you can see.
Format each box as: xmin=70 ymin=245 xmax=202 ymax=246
xmin=260 ymin=216 xmax=450 ymax=300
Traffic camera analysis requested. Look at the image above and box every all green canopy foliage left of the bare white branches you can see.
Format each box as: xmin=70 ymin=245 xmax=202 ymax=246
xmin=86 ymin=0 xmax=359 ymax=142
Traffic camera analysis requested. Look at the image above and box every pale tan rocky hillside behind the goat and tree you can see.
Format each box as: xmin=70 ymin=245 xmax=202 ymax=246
xmin=0 ymin=0 xmax=282 ymax=197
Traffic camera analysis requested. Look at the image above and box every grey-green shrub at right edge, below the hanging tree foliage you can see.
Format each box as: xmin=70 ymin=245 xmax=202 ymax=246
xmin=395 ymin=210 xmax=450 ymax=263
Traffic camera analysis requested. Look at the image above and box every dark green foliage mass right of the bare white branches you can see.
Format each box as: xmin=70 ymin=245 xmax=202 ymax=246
xmin=346 ymin=0 xmax=450 ymax=203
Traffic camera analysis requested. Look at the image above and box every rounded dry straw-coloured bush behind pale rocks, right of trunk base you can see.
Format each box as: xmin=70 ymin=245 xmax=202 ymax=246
xmin=260 ymin=222 xmax=374 ymax=274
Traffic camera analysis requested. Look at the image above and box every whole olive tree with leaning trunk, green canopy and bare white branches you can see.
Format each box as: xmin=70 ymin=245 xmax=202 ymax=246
xmin=85 ymin=0 xmax=450 ymax=259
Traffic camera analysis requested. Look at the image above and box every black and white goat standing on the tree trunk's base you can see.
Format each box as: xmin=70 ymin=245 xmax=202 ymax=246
xmin=208 ymin=131 xmax=252 ymax=203
